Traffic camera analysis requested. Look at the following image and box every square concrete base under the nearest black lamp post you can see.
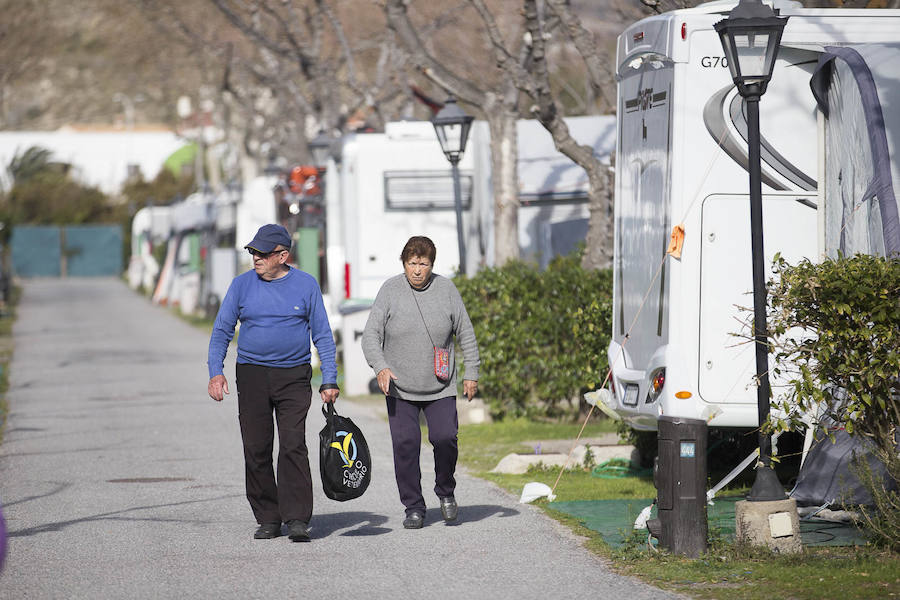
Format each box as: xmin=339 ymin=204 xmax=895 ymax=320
xmin=734 ymin=498 xmax=803 ymax=554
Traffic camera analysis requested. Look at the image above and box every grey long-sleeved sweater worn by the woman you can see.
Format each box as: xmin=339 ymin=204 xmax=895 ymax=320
xmin=362 ymin=274 xmax=481 ymax=401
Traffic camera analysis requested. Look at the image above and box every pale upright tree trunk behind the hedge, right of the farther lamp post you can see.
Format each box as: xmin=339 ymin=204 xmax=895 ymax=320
xmin=487 ymin=109 xmax=519 ymax=267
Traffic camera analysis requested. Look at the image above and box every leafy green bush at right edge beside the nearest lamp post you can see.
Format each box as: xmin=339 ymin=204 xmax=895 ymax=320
xmin=769 ymin=255 xmax=900 ymax=547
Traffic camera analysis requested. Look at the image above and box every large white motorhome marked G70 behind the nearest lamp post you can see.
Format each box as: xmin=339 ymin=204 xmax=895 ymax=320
xmin=608 ymin=0 xmax=900 ymax=429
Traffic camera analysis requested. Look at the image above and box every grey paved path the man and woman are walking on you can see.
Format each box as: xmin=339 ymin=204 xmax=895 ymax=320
xmin=0 ymin=279 xmax=674 ymax=600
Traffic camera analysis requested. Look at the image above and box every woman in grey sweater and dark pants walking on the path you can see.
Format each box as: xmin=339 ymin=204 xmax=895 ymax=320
xmin=362 ymin=236 xmax=480 ymax=529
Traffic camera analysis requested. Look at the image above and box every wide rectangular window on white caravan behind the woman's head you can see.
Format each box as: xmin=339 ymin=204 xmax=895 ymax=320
xmin=384 ymin=171 xmax=472 ymax=210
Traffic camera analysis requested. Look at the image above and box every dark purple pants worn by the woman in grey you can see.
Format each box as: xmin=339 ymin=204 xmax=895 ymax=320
xmin=387 ymin=396 xmax=459 ymax=516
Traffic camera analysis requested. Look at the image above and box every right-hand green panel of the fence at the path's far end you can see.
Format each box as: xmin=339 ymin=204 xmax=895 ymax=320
xmin=64 ymin=225 xmax=122 ymax=277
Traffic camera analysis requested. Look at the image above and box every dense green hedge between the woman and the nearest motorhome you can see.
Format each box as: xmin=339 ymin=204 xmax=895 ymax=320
xmin=456 ymin=253 xmax=612 ymax=418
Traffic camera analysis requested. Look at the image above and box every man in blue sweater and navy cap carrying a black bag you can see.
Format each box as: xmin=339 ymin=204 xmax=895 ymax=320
xmin=207 ymin=225 xmax=339 ymax=542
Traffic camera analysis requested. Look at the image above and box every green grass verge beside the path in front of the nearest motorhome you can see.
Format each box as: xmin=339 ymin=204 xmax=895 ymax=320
xmin=459 ymin=420 xmax=900 ymax=600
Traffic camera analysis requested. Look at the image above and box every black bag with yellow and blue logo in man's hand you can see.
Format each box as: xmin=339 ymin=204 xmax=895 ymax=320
xmin=319 ymin=402 xmax=372 ymax=502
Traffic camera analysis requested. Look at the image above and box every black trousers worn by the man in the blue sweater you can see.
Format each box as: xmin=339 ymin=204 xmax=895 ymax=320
xmin=235 ymin=363 xmax=313 ymax=524
